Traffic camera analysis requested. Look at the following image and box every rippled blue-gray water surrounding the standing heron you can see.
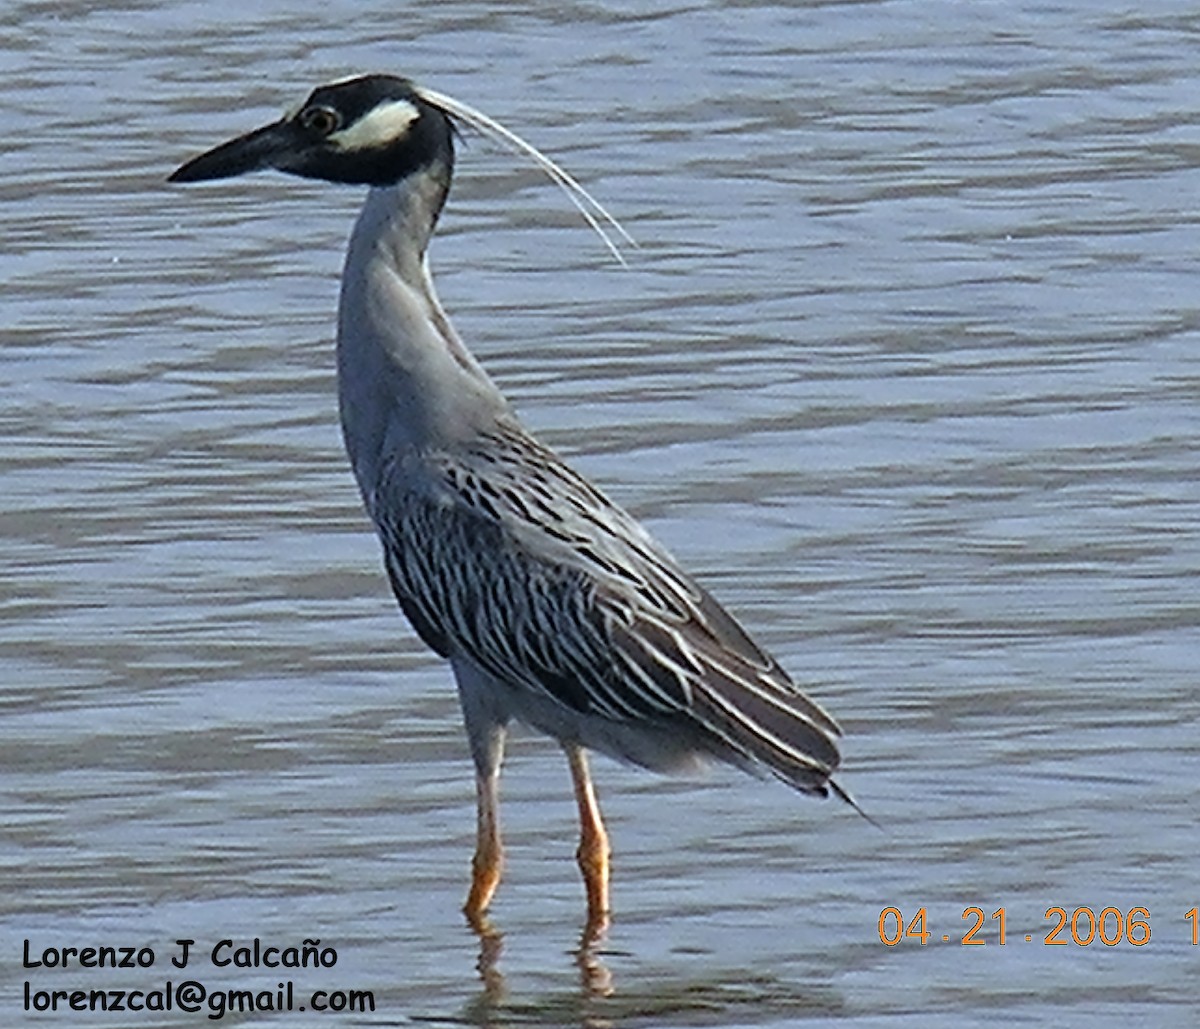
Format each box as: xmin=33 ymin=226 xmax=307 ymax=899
xmin=0 ymin=0 xmax=1200 ymax=1027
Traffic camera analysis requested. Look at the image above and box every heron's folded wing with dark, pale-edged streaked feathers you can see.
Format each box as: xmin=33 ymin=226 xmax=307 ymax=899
xmin=371 ymin=426 xmax=841 ymax=793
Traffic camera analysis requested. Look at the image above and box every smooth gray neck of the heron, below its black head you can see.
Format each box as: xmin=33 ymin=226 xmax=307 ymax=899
xmin=337 ymin=164 xmax=509 ymax=507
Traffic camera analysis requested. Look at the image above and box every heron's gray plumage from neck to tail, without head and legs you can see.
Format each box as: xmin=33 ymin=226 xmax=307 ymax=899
xmin=337 ymin=166 xmax=839 ymax=793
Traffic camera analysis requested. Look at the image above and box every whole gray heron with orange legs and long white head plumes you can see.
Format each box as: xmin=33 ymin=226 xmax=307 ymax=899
xmin=170 ymin=74 xmax=857 ymax=926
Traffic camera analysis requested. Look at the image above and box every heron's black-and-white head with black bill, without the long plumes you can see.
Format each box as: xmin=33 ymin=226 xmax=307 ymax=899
xmin=170 ymin=74 xmax=454 ymax=186
